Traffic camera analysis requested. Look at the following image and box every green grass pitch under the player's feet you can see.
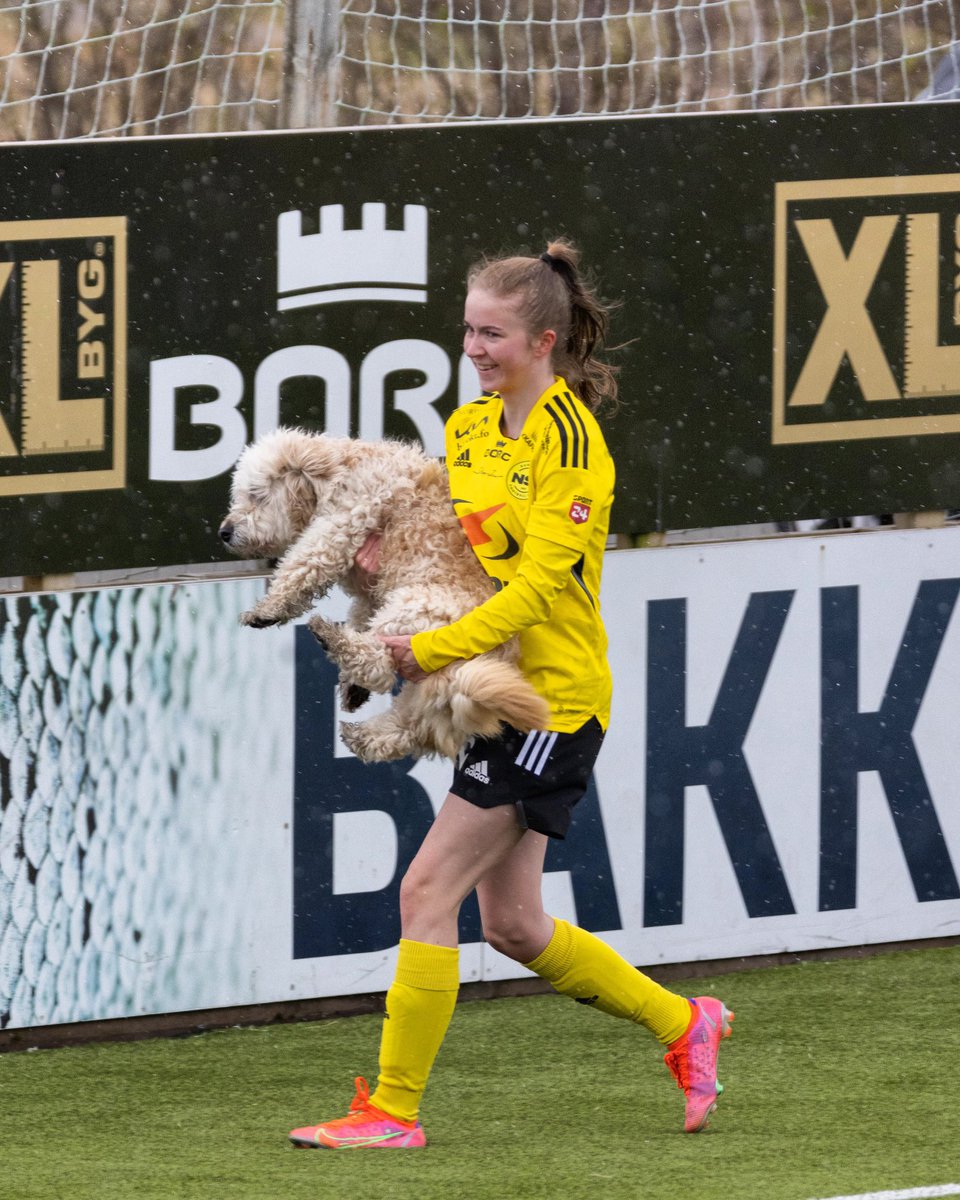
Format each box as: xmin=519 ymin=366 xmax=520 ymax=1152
xmin=0 ymin=948 xmax=960 ymax=1200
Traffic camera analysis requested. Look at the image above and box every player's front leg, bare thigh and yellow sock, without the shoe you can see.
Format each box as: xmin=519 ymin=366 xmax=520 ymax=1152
xmin=371 ymin=794 xmax=523 ymax=1122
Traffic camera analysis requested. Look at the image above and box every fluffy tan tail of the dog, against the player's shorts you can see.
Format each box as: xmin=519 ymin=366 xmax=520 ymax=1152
xmin=450 ymin=658 xmax=550 ymax=742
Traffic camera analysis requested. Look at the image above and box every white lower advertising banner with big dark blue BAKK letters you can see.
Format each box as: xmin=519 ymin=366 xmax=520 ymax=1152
xmin=0 ymin=529 xmax=960 ymax=1027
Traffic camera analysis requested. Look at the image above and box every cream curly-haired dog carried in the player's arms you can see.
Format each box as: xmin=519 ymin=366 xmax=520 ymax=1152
xmin=220 ymin=428 xmax=550 ymax=762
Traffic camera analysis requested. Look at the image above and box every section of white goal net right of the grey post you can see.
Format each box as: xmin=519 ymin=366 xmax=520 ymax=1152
xmin=337 ymin=0 xmax=959 ymax=124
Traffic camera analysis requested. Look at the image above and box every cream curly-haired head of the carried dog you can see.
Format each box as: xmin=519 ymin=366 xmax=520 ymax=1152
xmin=220 ymin=428 xmax=347 ymax=558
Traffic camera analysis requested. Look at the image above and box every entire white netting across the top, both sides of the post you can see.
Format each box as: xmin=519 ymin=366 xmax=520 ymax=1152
xmin=0 ymin=0 xmax=960 ymax=140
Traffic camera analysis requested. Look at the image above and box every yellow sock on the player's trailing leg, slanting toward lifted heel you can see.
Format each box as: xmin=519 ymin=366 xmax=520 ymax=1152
xmin=526 ymin=920 xmax=692 ymax=1045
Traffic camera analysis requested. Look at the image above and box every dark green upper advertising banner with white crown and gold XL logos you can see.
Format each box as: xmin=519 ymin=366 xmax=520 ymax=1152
xmin=0 ymin=103 xmax=960 ymax=576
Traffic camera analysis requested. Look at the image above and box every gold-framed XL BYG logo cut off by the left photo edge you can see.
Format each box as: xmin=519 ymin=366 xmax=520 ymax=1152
xmin=0 ymin=217 xmax=126 ymax=496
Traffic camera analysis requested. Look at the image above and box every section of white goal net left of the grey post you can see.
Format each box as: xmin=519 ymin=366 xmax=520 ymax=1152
xmin=0 ymin=0 xmax=285 ymax=142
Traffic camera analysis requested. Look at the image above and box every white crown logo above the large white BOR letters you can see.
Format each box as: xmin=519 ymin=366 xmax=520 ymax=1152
xmin=277 ymin=204 xmax=427 ymax=312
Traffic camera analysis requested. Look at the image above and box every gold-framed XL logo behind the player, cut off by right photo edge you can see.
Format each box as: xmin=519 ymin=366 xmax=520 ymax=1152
xmin=773 ymin=175 xmax=960 ymax=443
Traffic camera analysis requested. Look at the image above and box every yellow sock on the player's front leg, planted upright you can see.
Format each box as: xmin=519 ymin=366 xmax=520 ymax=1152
xmin=370 ymin=938 xmax=460 ymax=1121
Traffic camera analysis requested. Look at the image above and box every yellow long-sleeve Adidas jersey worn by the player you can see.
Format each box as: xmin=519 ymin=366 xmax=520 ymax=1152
xmin=412 ymin=378 xmax=614 ymax=733
